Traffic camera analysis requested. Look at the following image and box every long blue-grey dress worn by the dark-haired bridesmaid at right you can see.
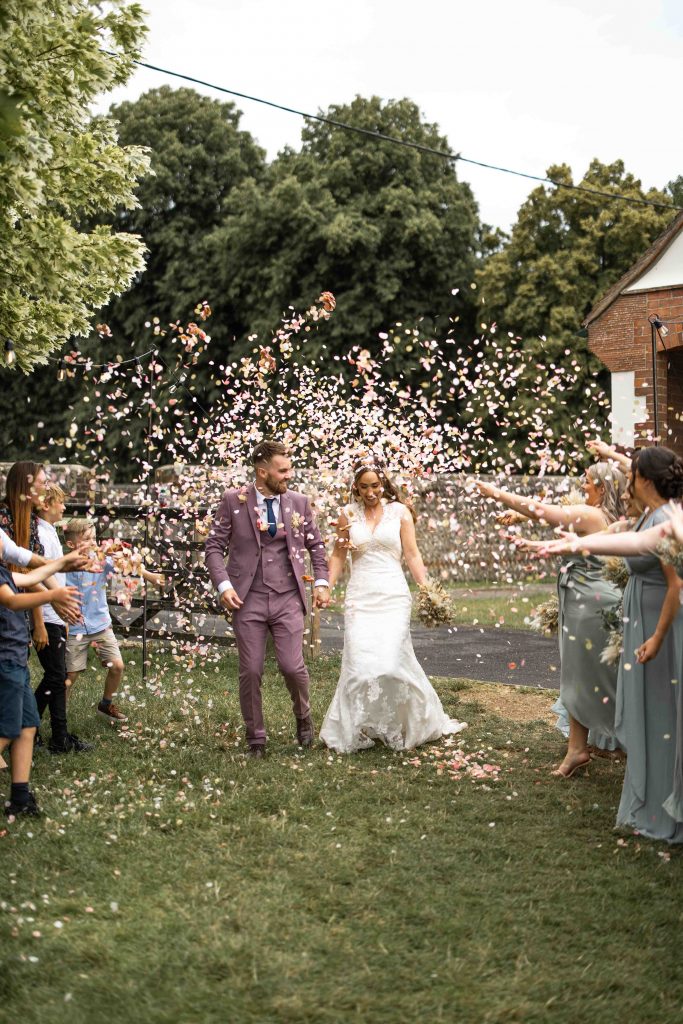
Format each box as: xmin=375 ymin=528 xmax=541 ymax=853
xmin=615 ymin=506 xmax=683 ymax=843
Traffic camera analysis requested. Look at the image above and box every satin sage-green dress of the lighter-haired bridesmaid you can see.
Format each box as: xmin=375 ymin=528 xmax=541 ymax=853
xmin=555 ymin=555 xmax=622 ymax=749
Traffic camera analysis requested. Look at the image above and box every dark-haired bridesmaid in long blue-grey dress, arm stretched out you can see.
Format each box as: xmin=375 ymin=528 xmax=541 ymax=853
xmin=543 ymin=447 xmax=683 ymax=843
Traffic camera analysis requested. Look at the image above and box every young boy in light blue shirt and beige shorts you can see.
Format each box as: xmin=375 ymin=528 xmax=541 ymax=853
xmin=63 ymin=519 xmax=164 ymax=725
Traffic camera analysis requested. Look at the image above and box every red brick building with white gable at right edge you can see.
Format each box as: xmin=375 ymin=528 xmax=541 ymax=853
xmin=584 ymin=213 xmax=683 ymax=455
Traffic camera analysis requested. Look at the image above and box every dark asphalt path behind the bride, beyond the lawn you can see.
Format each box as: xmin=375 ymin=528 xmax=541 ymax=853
xmin=321 ymin=612 xmax=560 ymax=689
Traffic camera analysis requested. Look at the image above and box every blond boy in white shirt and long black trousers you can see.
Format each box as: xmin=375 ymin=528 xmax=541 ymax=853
xmin=33 ymin=480 xmax=92 ymax=754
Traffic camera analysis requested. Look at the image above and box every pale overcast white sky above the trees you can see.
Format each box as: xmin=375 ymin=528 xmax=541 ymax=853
xmin=97 ymin=0 xmax=683 ymax=229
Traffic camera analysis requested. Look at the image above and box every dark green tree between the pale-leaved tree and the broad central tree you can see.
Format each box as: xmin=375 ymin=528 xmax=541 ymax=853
xmin=101 ymin=86 xmax=265 ymax=343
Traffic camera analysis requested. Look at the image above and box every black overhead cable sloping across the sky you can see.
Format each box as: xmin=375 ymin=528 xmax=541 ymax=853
xmin=120 ymin=50 xmax=683 ymax=211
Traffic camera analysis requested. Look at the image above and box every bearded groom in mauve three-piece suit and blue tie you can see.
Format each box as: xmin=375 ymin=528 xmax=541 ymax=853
xmin=205 ymin=440 xmax=330 ymax=758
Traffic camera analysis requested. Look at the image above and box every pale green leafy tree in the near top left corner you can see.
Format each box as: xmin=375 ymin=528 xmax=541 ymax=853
xmin=0 ymin=0 xmax=148 ymax=371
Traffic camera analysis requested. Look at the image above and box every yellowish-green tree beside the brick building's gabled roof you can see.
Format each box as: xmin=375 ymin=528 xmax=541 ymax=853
xmin=477 ymin=160 xmax=675 ymax=430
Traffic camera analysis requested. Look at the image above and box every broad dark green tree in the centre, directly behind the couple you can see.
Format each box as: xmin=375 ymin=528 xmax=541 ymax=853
xmin=199 ymin=96 xmax=479 ymax=368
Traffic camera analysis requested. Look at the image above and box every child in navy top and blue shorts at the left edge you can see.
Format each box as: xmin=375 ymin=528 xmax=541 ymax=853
xmin=0 ymin=542 xmax=83 ymax=817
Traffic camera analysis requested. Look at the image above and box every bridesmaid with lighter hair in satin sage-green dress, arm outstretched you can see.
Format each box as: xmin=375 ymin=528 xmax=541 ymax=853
xmin=478 ymin=463 xmax=626 ymax=778
